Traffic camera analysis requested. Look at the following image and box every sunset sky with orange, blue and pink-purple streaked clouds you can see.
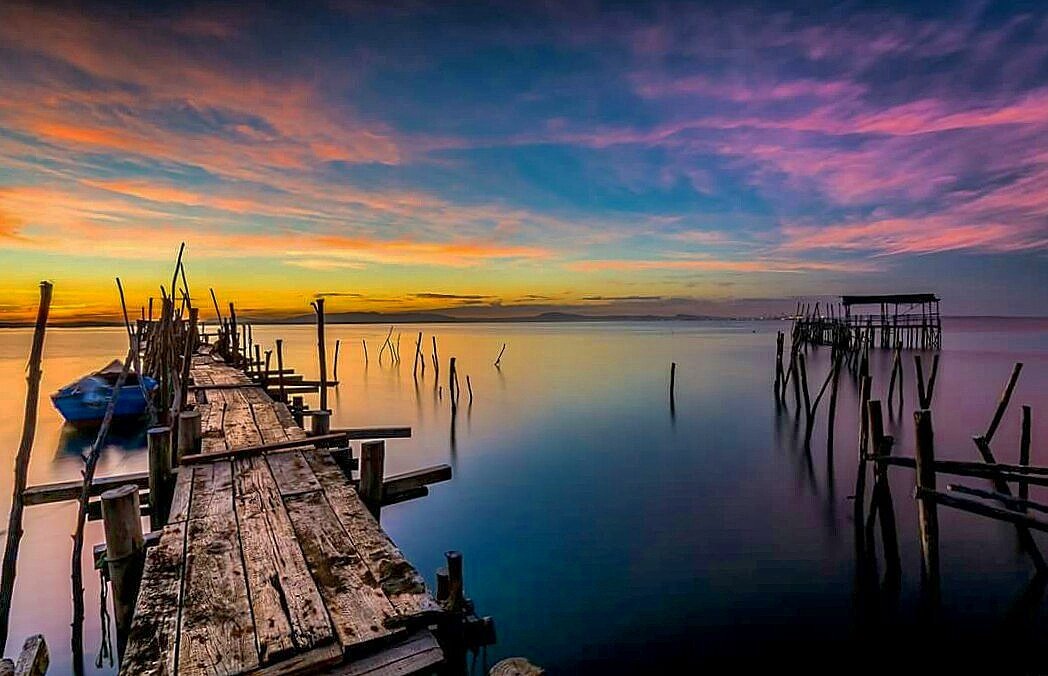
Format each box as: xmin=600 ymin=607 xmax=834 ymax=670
xmin=0 ymin=0 xmax=1048 ymax=322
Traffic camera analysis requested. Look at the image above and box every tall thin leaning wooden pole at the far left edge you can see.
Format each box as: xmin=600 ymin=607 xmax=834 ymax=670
xmin=0 ymin=282 xmax=52 ymax=656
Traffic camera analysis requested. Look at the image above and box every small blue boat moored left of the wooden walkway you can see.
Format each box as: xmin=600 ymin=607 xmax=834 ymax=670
xmin=51 ymin=359 xmax=156 ymax=426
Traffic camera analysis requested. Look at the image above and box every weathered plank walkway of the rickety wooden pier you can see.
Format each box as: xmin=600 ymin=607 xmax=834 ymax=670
xmin=121 ymin=354 xmax=444 ymax=675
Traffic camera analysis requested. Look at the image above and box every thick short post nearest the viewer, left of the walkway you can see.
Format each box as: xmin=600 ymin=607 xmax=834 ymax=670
xmin=102 ymin=484 xmax=146 ymax=655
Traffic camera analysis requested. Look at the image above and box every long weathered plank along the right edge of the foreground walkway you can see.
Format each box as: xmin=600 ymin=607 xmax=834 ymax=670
xmin=303 ymin=451 xmax=443 ymax=624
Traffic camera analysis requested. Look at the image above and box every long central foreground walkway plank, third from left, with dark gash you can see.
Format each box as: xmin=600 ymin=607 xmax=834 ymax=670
xmin=235 ymin=457 xmax=333 ymax=663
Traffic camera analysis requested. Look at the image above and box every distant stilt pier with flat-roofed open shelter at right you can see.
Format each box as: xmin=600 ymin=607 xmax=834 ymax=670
xmin=793 ymin=293 xmax=942 ymax=350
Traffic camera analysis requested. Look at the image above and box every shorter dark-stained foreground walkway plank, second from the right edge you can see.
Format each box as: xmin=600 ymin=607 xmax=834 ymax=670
xmin=284 ymin=490 xmax=395 ymax=648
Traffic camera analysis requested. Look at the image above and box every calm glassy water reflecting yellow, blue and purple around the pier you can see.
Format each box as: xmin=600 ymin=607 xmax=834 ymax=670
xmin=0 ymin=320 xmax=1048 ymax=674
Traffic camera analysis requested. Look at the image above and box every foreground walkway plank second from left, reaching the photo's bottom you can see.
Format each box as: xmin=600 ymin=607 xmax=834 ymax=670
xmin=178 ymin=462 xmax=259 ymax=675
